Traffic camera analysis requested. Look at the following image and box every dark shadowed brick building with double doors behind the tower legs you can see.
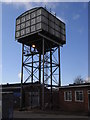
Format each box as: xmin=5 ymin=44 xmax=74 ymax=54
xmin=2 ymin=82 xmax=59 ymax=110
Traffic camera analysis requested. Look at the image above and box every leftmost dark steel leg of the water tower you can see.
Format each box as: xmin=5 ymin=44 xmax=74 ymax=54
xmin=20 ymin=44 xmax=24 ymax=110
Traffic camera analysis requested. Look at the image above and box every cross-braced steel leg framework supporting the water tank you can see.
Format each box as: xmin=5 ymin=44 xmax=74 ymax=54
xmin=20 ymin=37 xmax=61 ymax=109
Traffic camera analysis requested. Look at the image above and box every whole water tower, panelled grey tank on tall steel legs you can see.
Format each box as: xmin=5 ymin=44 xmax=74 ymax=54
xmin=15 ymin=7 xmax=66 ymax=108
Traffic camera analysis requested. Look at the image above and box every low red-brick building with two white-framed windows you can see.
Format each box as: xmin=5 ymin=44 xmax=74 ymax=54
xmin=59 ymin=83 xmax=90 ymax=113
